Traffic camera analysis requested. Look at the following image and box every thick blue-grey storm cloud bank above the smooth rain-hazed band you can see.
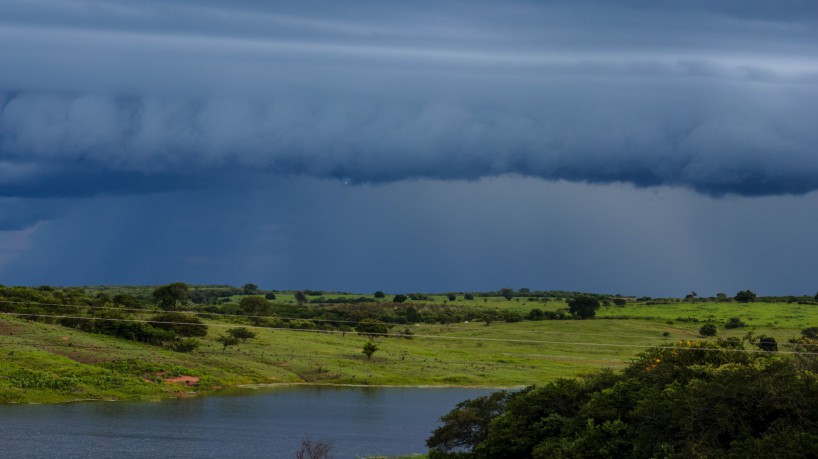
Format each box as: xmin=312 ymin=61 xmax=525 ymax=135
xmin=0 ymin=1 xmax=818 ymax=196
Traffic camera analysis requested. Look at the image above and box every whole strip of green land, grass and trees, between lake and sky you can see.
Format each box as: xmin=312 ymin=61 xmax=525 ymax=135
xmin=0 ymin=283 xmax=818 ymax=403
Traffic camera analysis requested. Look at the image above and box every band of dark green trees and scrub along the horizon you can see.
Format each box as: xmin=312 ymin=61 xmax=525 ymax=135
xmin=0 ymin=282 xmax=816 ymax=350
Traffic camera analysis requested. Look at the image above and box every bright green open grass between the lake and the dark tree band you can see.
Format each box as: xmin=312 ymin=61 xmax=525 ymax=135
xmin=0 ymin=295 xmax=818 ymax=403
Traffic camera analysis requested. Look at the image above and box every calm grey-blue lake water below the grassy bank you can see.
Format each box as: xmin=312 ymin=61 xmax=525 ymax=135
xmin=0 ymin=386 xmax=492 ymax=458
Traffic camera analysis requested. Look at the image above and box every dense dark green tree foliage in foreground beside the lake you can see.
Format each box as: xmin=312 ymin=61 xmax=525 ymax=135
xmin=427 ymin=340 xmax=818 ymax=459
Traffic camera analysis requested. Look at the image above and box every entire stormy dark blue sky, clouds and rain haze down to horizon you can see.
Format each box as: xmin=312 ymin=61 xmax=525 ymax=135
xmin=0 ymin=0 xmax=818 ymax=296
